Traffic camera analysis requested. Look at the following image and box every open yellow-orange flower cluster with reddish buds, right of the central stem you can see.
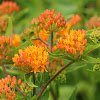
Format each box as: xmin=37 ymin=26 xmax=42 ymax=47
xmin=56 ymin=30 xmax=87 ymax=58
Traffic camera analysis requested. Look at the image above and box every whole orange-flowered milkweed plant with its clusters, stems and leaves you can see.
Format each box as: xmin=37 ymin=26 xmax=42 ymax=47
xmin=0 ymin=1 xmax=100 ymax=100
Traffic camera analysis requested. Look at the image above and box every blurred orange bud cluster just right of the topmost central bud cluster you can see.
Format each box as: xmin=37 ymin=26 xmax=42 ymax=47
xmin=66 ymin=14 xmax=82 ymax=26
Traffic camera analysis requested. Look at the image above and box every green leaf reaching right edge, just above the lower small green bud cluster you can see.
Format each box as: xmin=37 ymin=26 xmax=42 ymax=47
xmin=82 ymin=56 xmax=100 ymax=64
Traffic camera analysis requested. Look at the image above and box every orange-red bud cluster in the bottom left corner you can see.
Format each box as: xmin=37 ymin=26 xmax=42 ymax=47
xmin=0 ymin=75 xmax=21 ymax=100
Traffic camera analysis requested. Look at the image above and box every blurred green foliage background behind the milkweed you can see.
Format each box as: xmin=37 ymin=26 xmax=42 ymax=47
xmin=0 ymin=0 xmax=100 ymax=100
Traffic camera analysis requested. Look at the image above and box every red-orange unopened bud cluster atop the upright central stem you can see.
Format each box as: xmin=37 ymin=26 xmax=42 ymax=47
xmin=31 ymin=9 xmax=66 ymax=33
